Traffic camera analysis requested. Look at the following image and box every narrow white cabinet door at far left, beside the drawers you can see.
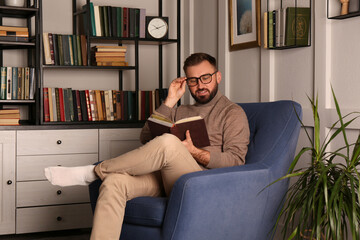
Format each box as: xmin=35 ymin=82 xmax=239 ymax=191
xmin=0 ymin=131 xmax=15 ymax=234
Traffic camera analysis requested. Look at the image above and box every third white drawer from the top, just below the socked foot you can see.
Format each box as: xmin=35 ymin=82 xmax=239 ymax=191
xmin=16 ymin=181 xmax=90 ymax=207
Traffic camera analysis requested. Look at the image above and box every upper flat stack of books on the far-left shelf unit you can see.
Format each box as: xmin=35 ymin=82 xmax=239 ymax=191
xmin=0 ymin=26 xmax=29 ymax=42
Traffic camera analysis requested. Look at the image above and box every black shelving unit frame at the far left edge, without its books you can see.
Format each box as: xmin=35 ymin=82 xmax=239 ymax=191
xmin=0 ymin=0 xmax=41 ymax=125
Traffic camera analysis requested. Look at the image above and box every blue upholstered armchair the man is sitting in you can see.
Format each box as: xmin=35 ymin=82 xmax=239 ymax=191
xmin=89 ymin=101 xmax=302 ymax=240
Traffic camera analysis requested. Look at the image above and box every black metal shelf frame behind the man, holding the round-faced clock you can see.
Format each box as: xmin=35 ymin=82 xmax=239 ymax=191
xmin=37 ymin=0 xmax=181 ymax=128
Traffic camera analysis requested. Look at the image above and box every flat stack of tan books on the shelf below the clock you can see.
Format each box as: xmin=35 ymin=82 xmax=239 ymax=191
xmin=92 ymin=46 xmax=129 ymax=66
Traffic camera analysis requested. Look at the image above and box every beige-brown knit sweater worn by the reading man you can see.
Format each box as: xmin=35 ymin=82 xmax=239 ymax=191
xmin=140 ymin=91 xmax=250 ymax=168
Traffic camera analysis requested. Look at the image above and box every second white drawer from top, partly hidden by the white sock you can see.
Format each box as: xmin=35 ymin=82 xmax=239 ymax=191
xmin=17 ymin=153 xmax=98 ymax=181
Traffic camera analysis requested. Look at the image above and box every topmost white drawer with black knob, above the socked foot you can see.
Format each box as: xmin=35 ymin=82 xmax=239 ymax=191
xmin=17 ymin=129 xmax=98 ymax=155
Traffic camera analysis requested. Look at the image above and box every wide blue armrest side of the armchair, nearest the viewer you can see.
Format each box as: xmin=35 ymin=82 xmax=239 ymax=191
xmin=163 ymin=164 xmax=270 ymax=240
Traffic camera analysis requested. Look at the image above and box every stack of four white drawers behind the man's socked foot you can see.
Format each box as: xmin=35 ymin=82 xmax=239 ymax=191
xmin=16 ymin=129 xmax=99 ymax=233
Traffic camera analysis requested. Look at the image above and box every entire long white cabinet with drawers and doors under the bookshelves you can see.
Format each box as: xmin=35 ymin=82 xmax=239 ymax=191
xmin=0 ymin=128 xmax=141 ymax=235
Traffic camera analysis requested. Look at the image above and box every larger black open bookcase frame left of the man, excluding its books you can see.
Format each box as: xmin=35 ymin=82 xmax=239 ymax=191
xmin=39 ymin=0 xmax=181 ymax=128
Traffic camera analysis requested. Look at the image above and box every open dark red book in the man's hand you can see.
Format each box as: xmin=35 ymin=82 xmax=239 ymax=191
xmin=148 ymin=114 xmax=210 ymax=148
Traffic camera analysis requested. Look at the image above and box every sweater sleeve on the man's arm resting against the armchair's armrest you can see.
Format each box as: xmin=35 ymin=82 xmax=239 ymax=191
xmin=206 ymin=108 xmax=250 ymax=168
